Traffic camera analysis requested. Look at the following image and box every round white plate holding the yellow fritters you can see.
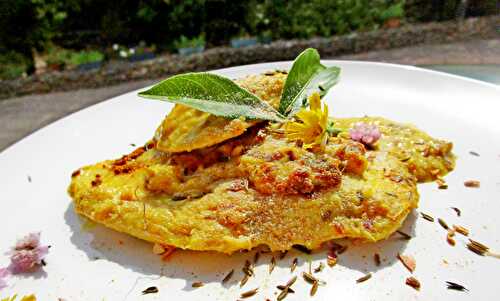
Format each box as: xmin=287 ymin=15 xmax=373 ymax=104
xmin=0 ymin=61 xmax=500 ymax=301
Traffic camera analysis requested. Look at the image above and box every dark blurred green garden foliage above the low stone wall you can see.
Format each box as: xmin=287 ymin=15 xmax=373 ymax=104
xmin=0 ymin=0 xmax=498 ymax=79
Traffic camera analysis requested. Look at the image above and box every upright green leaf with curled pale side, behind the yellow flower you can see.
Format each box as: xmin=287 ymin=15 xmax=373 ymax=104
xmin=279 ymin=48 xmax=340 ymax=116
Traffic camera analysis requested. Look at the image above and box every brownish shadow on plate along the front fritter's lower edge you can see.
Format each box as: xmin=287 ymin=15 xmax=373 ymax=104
xmin=65 ymin=204 xmax=416 ymax=291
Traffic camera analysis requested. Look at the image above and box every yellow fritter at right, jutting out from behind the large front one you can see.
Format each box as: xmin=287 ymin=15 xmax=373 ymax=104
xmin=334 ymin=117 xmax=455 ymax=182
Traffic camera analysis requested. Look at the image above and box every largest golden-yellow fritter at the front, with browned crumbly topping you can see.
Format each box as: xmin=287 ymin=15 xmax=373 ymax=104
xmin=69 ymin=128 xmax=418 ymax=253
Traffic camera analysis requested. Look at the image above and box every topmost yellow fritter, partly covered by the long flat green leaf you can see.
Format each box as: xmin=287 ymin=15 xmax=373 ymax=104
xmin=156 ymin=72 xmax=286 ymax=152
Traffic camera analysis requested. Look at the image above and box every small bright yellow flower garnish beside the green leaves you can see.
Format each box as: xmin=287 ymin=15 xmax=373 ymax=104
xmin=285 ymin=92 xmax=328 ymax=149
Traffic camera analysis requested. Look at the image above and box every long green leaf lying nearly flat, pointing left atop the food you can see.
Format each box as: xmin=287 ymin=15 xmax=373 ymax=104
xmin=139 ymin=72 xmax=285 ymax=122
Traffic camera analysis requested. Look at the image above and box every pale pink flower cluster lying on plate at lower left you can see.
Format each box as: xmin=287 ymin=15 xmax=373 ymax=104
xmin=9 ymin=233 xmax=49 ymax=274
